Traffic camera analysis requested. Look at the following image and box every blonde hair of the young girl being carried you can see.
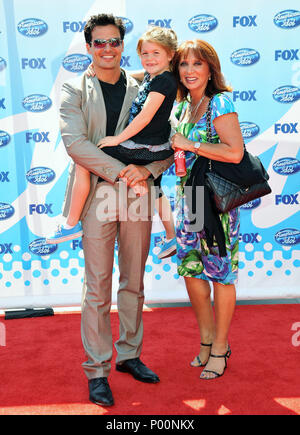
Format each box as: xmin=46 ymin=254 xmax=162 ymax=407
xmin=136 ymin=26 xmax=177 ymax=56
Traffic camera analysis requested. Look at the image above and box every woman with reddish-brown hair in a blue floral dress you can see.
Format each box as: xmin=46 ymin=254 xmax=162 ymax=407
xmin=172 ymin=40 xmax=243 ymax=379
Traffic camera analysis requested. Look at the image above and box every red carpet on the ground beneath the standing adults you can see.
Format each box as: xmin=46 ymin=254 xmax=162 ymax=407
xmin=0 ymin=305 xmax=300 ymax=416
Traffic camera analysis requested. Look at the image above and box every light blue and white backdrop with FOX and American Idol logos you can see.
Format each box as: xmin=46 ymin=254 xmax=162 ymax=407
xmin=0 ymin=0 xmax=300 ymax=308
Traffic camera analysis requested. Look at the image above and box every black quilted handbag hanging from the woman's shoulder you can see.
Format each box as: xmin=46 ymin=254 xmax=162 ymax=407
xmin=205 ymin=100 xmax=271 ymax=213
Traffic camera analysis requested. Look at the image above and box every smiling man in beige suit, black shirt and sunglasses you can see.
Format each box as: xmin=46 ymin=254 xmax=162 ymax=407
xmin=60 ymin=14 xmax=172 ymax=406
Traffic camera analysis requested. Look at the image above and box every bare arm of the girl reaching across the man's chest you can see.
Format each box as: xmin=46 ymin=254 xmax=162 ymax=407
xmin=98 ymin=92 xmax=165 ymax=148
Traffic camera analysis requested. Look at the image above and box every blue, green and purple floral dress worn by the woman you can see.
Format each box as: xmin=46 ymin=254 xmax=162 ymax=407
xmin=175 ymin=94 xmax=240 ymax=284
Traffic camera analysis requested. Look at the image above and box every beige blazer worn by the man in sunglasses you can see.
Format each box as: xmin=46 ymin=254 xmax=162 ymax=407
xmin=60 ymin=72 xmax=173 ymax=219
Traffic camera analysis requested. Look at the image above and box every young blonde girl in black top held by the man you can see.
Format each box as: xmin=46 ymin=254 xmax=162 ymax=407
xmin=46 ymin=26 xmax=177 ymax=258
